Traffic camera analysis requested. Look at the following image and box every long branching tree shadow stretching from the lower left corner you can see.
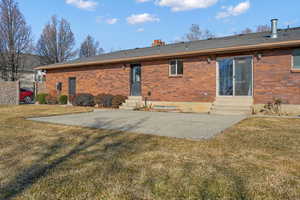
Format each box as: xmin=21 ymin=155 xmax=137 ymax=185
xmin=0 ymin=115 xmax=147 ymax=200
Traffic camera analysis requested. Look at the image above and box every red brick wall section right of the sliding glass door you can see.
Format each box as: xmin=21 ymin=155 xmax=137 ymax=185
xmin=254 ymin=50 xmax=300 ymax=104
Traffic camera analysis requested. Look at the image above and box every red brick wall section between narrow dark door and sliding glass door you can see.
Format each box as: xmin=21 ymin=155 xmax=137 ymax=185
xmin=142 ymin=57 xmax=216 ymax=102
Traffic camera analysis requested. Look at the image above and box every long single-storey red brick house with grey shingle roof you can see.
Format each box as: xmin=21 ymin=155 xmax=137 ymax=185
xmin=36 ymin=20 xmax=300 ymax=113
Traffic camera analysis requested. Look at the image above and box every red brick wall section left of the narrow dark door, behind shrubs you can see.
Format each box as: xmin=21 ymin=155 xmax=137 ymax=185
xmin=46 ymin=65 xmax=130 ymax=96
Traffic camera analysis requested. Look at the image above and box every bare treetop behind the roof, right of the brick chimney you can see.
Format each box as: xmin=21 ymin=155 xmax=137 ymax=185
xmin=184 ymin=24 xmax=215 ymax=41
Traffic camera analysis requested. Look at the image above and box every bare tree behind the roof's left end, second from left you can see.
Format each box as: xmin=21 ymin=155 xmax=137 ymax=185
xmin=36 ymin=16 xmax=77 ymax=64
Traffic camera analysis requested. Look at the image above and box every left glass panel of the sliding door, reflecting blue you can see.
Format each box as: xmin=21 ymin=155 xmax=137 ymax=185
xmin=219 ymin=59 xmax=233 ymax=96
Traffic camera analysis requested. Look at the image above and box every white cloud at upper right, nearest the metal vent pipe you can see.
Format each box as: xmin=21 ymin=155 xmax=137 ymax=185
xmin=216 ymin=1 xmax=251 ymax=19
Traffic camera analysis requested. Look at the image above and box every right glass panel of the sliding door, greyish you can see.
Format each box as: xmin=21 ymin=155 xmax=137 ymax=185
xmin=234 ymin=57 xmax=252 ymax=96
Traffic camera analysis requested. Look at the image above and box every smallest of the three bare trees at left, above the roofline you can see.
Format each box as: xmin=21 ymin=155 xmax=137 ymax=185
xmin=79 ymin=35 xmax=104 ymax=58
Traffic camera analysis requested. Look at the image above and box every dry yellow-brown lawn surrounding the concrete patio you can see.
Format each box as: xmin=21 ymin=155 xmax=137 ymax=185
xmin=0 ymin=105 xmax=300 ymax=200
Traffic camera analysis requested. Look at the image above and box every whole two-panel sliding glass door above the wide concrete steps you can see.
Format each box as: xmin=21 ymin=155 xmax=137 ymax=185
xmin=218 ymin=57 xmax=253 ymax=96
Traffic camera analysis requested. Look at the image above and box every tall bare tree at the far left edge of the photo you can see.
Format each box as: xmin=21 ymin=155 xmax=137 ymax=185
xmin=0 ymin=0 xmax=32 ymax=81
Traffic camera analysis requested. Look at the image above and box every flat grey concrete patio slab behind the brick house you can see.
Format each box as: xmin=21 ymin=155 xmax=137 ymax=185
xmin=30 ymin=110 xmax=246 ymax=139
